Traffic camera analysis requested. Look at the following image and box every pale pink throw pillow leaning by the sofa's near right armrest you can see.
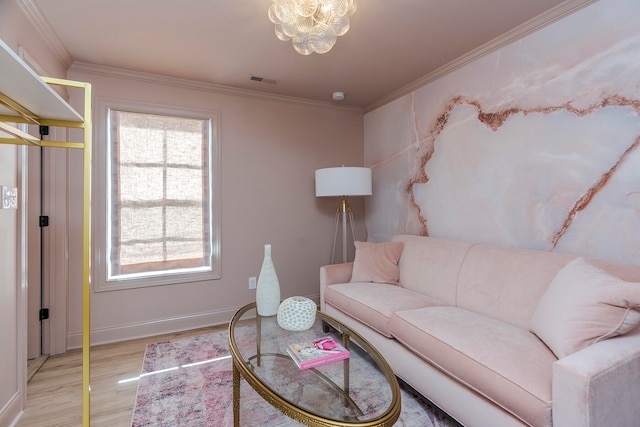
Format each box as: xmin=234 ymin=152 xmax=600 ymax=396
xmin=530 ymin=258 xmax=640 ymax=358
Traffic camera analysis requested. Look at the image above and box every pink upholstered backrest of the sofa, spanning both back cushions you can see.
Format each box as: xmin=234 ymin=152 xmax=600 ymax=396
xmin=392 ymin=235 xmax=640 ymax=330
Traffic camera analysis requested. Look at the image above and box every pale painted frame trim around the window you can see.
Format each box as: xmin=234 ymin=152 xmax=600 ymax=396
xmin=91 ymin=97 xmax=221 ymax=292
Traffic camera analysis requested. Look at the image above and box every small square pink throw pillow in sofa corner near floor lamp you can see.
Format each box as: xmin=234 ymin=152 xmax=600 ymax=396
xmin=351 ymin=242 xmax=404 ymax=285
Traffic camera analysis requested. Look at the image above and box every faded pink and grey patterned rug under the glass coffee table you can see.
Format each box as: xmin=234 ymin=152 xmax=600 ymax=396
xmin=131 ymin=331 xmax=457 ymax=427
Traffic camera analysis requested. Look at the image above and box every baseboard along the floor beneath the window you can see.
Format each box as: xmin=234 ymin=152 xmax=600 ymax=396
xmin=67 ymin=307 xmax=239 ymax=352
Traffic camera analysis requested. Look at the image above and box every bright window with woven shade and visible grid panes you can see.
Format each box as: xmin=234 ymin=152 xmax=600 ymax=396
xmin=97 ymin=98 xmax=219 ymax=290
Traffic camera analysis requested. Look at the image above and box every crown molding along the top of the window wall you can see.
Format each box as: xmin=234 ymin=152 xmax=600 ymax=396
xmin=69 ymin=61 xmax=364 ymax=113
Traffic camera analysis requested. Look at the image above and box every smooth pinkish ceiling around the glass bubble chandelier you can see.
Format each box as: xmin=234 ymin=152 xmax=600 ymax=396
xmin=27 ymin=0 xmax=593 ymax=110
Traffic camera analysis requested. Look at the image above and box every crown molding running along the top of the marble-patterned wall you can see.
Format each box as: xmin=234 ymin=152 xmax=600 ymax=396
xmin=364 ymin=0 xmax=598 ymax=113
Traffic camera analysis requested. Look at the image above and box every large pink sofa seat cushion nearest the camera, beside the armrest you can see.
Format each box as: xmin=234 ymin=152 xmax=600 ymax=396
xmin=390 ymin=307 xmax=557 ymax=426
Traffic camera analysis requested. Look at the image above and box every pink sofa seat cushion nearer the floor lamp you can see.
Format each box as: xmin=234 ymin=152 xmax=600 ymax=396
xmin=324 ymin=282 xmax=442 ymax=338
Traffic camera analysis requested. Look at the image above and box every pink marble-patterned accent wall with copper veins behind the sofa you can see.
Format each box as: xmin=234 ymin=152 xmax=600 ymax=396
xmin=365 ymin=0 xmax=640 ymax=264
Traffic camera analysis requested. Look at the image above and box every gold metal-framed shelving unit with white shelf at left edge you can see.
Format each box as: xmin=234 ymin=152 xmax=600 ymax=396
xmin=0 ymin=39 xmax=91 ymax=427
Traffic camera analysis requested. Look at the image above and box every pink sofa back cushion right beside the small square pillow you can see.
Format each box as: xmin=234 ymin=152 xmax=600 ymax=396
xmin=392 ymin=235 xmax=472 ymax=306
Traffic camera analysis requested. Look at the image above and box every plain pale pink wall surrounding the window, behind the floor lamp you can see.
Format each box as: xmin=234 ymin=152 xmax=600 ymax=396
xmin=68 ymin=64 xmax=364 ymax=347
